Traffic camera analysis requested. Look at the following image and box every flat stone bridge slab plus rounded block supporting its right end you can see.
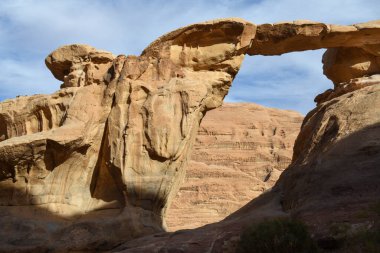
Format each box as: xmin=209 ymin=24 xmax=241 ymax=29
xmin=247 ymin=20 xmax=380 ymax=84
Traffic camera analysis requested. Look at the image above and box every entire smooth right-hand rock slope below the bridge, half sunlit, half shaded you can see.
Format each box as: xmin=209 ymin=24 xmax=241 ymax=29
xmin=112 ymin=72 xmax=380 ymax=253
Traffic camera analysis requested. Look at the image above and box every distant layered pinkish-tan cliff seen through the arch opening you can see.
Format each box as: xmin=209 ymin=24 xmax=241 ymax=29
xmin=166 ymin=103 xmax=303 ymax=231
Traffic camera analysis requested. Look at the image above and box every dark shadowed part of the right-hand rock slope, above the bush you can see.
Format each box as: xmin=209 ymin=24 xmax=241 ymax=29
xmin=112 ymin=120 xmax=380 ymax=253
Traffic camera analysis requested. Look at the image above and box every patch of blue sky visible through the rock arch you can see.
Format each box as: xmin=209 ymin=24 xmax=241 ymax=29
xmin=224 ymin=49 xmax=332 ymax=115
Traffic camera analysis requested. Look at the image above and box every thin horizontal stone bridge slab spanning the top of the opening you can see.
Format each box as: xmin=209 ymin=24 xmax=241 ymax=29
xmin=247 ymin=20 xmax=380 ymax=55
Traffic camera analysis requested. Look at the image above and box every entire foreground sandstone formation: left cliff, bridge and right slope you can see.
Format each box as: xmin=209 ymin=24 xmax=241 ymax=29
xmin=0 ymin=16 xmax=380 ymax=252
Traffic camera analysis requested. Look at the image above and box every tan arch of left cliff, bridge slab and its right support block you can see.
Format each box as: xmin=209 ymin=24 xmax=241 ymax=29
xmin=0 ymin=19 xmax=380 ymax=249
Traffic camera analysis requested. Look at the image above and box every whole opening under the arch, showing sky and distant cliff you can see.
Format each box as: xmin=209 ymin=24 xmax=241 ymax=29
xmin=166 ymin=49 xmax=331 ymax=231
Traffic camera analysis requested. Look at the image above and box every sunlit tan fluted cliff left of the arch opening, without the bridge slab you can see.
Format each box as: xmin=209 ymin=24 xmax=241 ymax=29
xmin=0 ymin=20 xmax=255 ymax=251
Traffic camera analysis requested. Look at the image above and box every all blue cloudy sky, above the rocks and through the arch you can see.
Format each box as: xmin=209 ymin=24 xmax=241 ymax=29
xmin=0 ymin=0 xmax=380 ymax=114
